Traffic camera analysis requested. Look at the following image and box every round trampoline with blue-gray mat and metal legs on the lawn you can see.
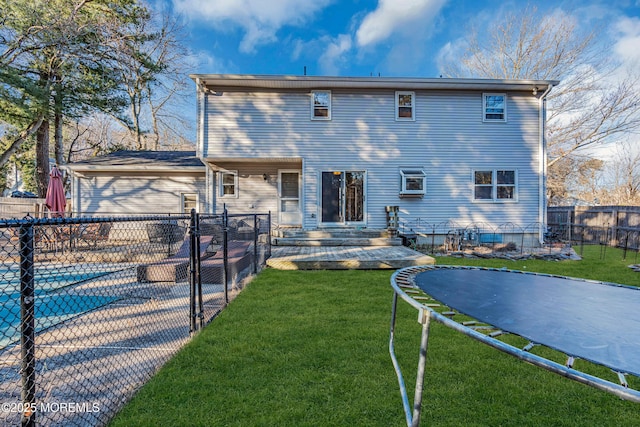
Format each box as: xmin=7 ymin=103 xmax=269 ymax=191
xmin=389 ymin=265 xmax=640 ymax=426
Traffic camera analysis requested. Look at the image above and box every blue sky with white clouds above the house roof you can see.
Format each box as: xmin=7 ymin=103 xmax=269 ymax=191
xmin=156 ymin=0 xmax=640 ymax=77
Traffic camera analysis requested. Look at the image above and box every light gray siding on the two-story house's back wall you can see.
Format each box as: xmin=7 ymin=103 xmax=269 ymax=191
xmin=203 ymin=89 xmax=543 ymax=228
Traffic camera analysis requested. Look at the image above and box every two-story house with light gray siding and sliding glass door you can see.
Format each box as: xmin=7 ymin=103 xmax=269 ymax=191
xmin=191 ymin=74 xmax=557 ymax=237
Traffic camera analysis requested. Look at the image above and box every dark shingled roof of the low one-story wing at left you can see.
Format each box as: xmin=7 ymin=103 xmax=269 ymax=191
xmin=65 ymin=150 xmax=205 ymax=172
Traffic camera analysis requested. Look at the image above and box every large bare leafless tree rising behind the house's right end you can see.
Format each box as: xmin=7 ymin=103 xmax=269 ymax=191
xmin=443 ymin=7 xmax=640 ymax=200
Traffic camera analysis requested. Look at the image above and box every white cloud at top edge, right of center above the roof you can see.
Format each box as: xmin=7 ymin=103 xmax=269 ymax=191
xmin=356 ymin=0 xmax=447 ymax=47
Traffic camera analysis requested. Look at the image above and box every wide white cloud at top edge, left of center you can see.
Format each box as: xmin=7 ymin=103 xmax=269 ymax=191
xmin=173 ymin=0 xmax=332 ymax=53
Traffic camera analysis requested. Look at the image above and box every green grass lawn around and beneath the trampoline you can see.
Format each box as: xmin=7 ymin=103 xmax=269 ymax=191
xmin=110 ymin=248 xmax=640 ymax=426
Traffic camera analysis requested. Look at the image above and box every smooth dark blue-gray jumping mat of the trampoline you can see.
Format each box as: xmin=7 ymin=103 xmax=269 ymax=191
xmin=415 ymin=268 xmax=640 ymax=376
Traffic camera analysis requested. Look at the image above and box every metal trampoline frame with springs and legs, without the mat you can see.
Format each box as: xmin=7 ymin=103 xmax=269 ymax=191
xmin=389 ymin=265 xmax=640 ymax=426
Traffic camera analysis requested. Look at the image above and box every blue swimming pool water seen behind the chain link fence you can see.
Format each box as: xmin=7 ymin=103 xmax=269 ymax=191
xmin=0 ymin=265 xmax=122 ymax=350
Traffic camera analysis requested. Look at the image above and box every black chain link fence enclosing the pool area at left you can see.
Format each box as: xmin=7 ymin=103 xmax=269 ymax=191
xmin=0 ymin=212 xmax=270 ymax=426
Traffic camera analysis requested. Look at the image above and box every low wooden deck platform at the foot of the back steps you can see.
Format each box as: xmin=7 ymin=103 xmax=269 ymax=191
xmin=267 ymin=246 xmax=435 ymax=270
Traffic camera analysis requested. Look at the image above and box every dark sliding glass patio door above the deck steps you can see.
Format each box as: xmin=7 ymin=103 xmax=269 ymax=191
xmin=321 ymin=171 xmax=365 ymax=225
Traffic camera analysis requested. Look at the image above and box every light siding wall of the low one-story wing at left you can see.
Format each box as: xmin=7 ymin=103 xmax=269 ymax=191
xmin=72 ymin=173 xmax=205 ymax=214
